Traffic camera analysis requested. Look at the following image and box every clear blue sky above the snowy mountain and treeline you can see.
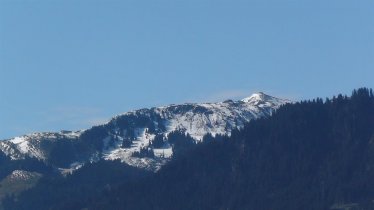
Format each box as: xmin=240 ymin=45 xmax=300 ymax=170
xmin=0 ymin=0 xmax=374 ymax=139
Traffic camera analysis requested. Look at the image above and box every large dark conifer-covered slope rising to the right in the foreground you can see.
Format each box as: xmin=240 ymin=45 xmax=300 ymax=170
xmin=5 ymin=88 xmax=374 ymax=210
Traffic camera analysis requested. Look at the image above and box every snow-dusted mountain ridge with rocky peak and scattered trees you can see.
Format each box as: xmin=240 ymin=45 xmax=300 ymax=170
xmin=0 ymin=92 xmax=290 ymax=173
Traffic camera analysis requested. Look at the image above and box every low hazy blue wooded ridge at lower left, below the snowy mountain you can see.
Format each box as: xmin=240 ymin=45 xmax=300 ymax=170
xmin=2 ymin=160 xmax=152 ymax=210
